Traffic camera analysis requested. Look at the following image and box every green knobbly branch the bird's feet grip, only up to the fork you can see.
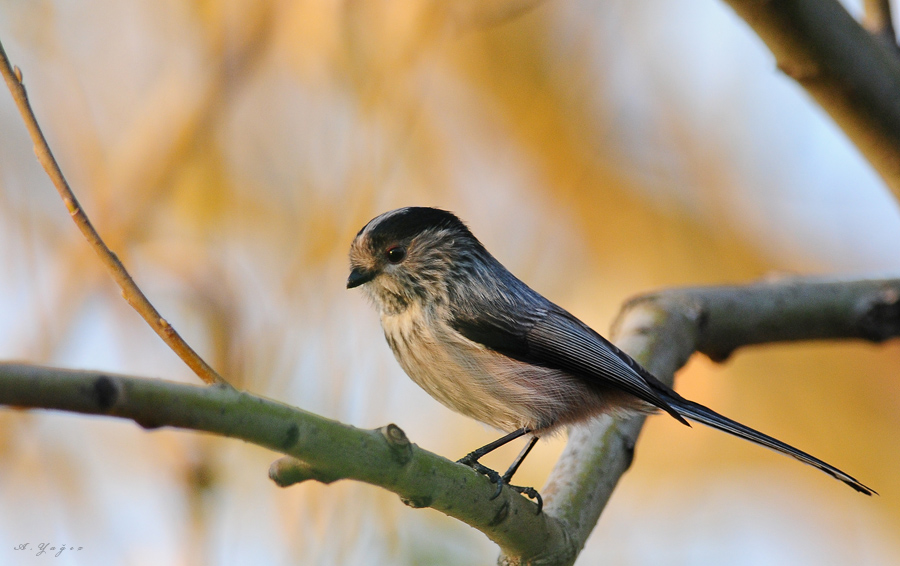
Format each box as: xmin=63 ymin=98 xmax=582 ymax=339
xmin=0 ymin=364 xmax=564 ymax=555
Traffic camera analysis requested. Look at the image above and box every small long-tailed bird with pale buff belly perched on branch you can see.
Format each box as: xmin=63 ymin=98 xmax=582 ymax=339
xmin=347 ymin=207 xmax=876 ymax=513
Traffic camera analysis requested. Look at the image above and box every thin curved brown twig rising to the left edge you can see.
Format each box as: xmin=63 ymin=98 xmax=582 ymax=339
xmin=0 ymin=36 xmax=228 ymax=385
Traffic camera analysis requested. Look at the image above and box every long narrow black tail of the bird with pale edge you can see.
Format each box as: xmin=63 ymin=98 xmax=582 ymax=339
xmin=666 ymin=393 xmax=877 ymax=495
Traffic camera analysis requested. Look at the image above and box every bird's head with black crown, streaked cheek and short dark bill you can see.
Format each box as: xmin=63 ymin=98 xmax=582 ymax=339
xmin=347 ymin=207 xmax=486 ymax=314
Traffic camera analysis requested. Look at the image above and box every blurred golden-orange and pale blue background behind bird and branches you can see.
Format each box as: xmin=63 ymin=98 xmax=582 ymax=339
xmin=0 ymin=0 xmax=900 ymax=566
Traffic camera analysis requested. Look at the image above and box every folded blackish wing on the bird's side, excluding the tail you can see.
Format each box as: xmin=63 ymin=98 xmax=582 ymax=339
xmin=451 ymin=298 xmax=688 ymax=424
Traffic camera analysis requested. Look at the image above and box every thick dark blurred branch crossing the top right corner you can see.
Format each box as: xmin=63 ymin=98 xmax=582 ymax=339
xmin=727 ymin=0 xmax=900 ymax=202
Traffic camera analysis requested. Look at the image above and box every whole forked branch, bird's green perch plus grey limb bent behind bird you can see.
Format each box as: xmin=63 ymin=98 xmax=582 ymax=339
xmin=0 ymin=279 xmax=900 ymax=564
